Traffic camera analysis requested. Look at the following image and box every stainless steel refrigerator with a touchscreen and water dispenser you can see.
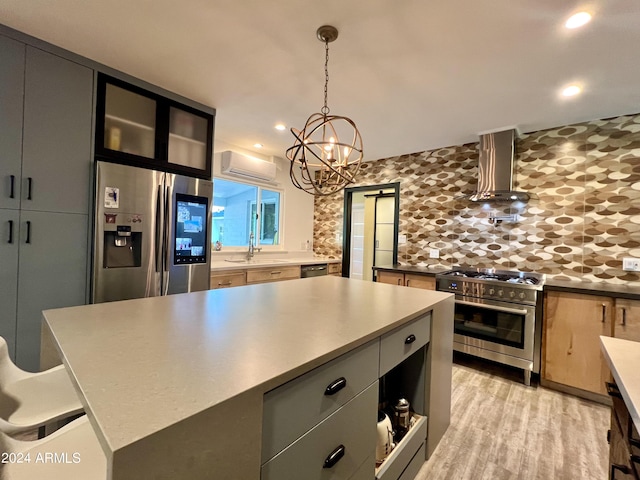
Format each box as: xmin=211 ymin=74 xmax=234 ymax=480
xmin=91 ymin=161 xmax=213 ymax=303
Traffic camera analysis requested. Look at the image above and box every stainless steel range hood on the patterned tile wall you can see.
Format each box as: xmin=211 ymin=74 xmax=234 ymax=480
xmin=469 ymin=130 xmax=529 ymax=202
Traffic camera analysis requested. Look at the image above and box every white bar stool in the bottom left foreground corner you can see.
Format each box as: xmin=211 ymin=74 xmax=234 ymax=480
xmin=0 ymin=415 xmax=107 ymax=480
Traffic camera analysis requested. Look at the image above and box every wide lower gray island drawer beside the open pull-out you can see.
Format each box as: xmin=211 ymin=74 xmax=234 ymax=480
xmin=261 ymin=381 xmax=378 ymax=480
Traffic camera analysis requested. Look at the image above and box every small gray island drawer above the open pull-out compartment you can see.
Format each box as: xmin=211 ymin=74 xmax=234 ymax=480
xmin=380 ymin=313 xmax=431 ymax=376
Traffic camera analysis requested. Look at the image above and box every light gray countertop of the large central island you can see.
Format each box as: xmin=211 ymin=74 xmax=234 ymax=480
xmin=44 ymin=276 xmax=453 ymax=478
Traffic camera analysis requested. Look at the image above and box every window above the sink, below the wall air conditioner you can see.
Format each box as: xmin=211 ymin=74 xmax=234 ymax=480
xmin=211 ymin=178 xmax=282 ymax=247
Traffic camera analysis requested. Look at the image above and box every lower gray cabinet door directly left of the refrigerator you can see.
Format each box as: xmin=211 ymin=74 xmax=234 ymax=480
xmin=16 ymin=210 xmax=88 ymax=371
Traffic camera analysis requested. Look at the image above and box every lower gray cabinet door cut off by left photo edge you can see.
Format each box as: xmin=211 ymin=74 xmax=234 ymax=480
xmin=0 ymin=209 xmax=19 ymax=360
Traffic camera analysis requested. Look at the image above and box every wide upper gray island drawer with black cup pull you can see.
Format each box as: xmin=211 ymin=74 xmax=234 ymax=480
xmin=262 ymin=340 xmax=380 ymax=463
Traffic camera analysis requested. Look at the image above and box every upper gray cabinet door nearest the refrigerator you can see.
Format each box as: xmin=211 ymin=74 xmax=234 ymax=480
xmin=21 ymin=46 xmax=93 ymax=214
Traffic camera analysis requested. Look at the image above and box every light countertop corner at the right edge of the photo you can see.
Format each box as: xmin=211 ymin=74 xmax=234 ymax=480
xmin=600 ymin=337 xmax=640 ymax=432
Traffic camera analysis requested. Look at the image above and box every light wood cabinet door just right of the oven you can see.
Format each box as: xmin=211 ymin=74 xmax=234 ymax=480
xmin=543 ymin=291 xmax=613 ymax=395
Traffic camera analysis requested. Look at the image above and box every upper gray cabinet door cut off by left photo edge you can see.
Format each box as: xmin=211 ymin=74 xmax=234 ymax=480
xmin=0 ymin=35 xmax=26 ymax=209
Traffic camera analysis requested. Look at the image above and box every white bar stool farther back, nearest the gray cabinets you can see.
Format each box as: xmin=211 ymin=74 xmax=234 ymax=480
xmin=0 ymin=337 xmax=83 ymax=435
